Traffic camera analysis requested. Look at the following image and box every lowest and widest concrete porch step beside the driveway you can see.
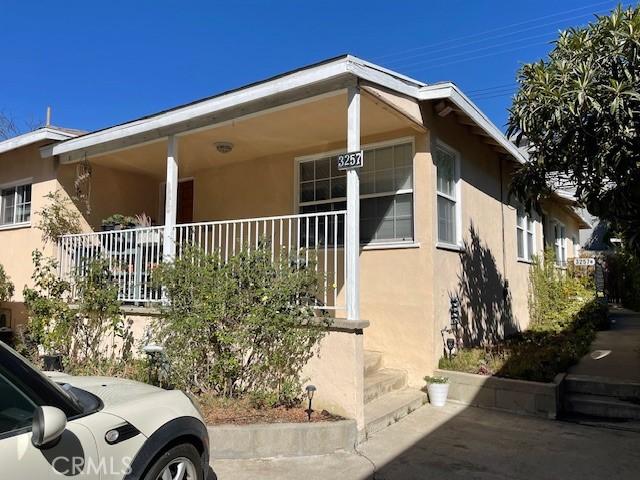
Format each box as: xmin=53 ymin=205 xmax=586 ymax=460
xmin=364 ymin=388 xmax=427 ymax=438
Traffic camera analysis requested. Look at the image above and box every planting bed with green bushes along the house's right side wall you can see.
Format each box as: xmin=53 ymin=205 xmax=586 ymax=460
xmin=439 ymin=251 xmax=607 ymax=382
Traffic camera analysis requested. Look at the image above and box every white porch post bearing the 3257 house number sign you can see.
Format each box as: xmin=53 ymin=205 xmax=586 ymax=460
xmin=345 ymin=84 xmax=360 ymax=320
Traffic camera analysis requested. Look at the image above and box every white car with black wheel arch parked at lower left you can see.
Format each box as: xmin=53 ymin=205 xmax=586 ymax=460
xmin=0 ymin=342 xmax=209 ymax=480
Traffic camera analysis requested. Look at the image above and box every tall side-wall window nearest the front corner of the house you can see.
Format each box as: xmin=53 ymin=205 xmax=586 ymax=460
xmin=435 ymin=145 xmax=461 ymax=245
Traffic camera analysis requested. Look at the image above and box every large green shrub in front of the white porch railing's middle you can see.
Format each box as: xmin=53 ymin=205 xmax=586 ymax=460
xmin=154 ymin=243 xmax=325 ymax=406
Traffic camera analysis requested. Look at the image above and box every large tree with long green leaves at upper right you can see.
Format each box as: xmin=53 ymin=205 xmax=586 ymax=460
xmin=508 ymin=7 xmax=640 ymax=252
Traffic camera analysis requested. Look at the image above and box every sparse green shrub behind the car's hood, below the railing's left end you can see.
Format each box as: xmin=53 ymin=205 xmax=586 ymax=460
xmin=20 ymin=250 xmax=133 ymax=374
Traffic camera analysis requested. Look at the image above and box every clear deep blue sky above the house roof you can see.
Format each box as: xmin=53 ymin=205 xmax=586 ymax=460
xmin=0 ymin=0 xmax=632 ymax=135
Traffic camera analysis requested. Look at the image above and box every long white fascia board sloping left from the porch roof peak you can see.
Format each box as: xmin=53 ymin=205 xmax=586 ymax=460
xmin=41 ymin=58 xmax=356 ymax=157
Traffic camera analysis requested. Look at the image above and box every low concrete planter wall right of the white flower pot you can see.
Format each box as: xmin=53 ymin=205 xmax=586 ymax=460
xmin=435 ymin=370 xmax=564 ymax=419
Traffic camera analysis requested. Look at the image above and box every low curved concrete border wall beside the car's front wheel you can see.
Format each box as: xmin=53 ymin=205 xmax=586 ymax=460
xmin=209 ymin=420 xmax=357 ymax=460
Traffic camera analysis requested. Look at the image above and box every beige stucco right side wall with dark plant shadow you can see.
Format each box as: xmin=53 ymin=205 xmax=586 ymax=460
xmin=425 ymin=110 xmax=542 ymax=366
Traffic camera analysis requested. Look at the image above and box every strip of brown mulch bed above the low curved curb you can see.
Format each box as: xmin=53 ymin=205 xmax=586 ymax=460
xmin=199 ymin=396 xmax=343 ymax=425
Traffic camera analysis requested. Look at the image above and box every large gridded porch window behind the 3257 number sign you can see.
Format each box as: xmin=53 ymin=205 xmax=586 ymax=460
xmin=298 ymin=141 xmax=413 ymax=244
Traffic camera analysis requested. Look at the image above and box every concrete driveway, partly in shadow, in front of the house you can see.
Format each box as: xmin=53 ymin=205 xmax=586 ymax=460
xmin=212 ymin=404 xmax=640 ymax=480
